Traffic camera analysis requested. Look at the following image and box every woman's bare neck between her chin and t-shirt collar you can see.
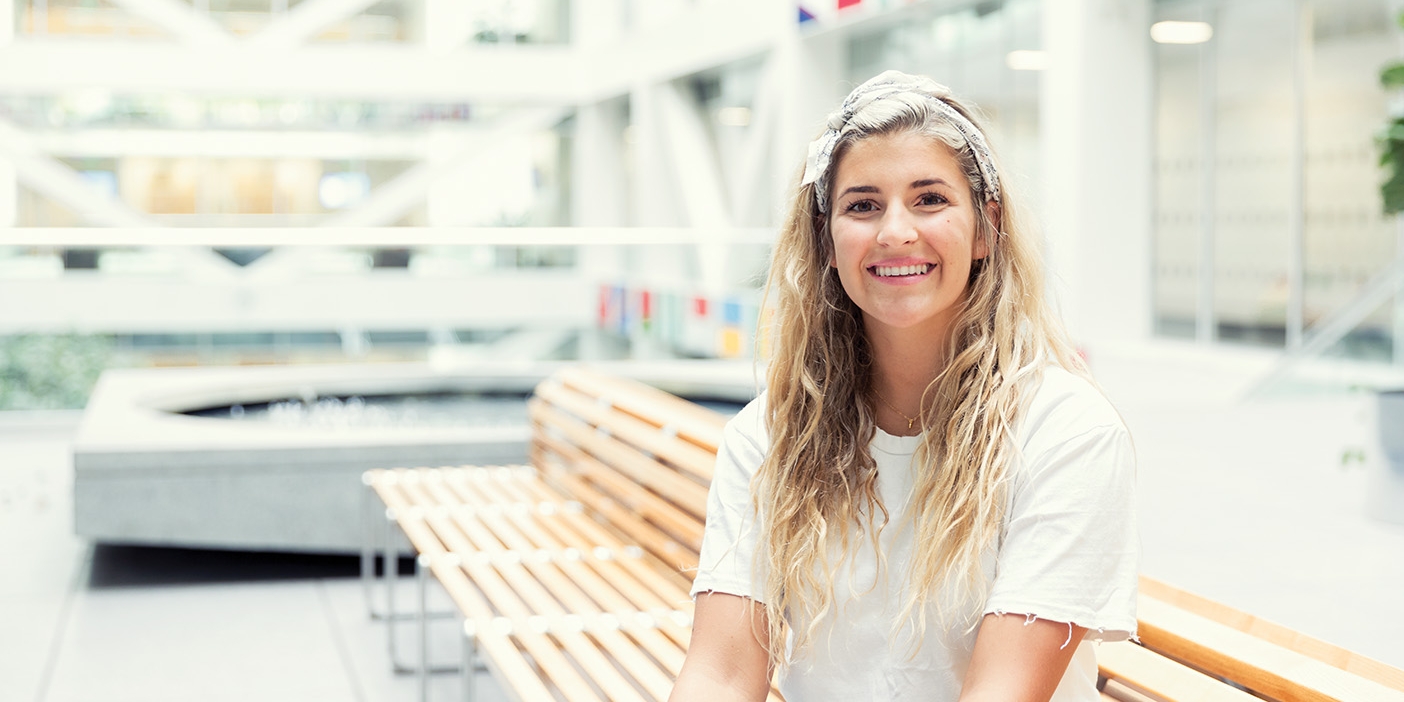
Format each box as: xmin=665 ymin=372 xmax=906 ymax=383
xmin=868 ymin=321 xmax=946 ymax=435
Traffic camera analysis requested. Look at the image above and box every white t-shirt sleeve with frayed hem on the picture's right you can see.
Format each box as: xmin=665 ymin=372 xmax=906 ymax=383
xmin=984 ymin=423 xmax=1140 ymax=642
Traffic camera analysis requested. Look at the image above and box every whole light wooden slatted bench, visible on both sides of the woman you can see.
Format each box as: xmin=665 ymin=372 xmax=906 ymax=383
xmin=362 ymin=369 xmax=1404 ymax=702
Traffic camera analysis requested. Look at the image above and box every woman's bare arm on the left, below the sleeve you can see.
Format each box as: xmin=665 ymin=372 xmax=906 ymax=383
xmin=668 ymin=592 xmax=771 ymax=702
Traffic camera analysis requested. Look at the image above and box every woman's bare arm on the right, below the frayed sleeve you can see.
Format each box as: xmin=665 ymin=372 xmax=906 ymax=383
xmin=960 ymin=614 xmax=1087 ymax=702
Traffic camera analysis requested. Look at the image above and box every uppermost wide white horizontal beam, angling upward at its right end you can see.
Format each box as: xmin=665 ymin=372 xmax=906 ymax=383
xmin=0 ymin=0 xmax=779 ymax=107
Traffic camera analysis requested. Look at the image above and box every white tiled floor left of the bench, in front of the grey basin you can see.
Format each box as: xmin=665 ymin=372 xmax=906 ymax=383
xmin=0 ymin=415 xmax=505 ymax=702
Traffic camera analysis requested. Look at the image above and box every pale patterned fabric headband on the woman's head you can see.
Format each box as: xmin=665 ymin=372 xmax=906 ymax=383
xmin=800 ymin=70 xmax=1000 ymax=213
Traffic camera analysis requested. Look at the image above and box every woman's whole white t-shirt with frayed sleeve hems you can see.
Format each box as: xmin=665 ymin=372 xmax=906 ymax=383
xmin=692 ymin=366 xmax=1140 ymax=702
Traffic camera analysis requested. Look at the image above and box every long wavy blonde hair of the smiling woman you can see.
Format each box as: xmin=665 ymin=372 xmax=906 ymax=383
xmin=753 ymin=76 xmax=1087 ymax=667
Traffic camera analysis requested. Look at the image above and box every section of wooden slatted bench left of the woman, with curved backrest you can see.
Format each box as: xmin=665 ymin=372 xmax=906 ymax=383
xmin=362 ymin=368 xmax=786 ymax=702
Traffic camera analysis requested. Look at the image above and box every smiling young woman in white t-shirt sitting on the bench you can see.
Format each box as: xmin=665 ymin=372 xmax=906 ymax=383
xmin=673 ymin=72 xmax=1137 ymax=702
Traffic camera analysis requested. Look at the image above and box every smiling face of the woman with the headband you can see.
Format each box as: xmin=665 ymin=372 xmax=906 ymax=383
xmin=830 ymin=132 xmax=987 ymax=338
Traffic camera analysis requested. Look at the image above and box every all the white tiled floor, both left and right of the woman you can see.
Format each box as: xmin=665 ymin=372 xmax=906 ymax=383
xmin=8 ymin=350 xmax=1404 ymax=702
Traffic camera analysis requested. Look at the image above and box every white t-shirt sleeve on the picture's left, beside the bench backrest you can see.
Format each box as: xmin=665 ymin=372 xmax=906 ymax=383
xmin=692 ymin=400 xmax=768 ymax=598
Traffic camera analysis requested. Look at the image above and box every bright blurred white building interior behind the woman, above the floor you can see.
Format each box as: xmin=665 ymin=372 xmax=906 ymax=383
xmin=0 ymin=0 xmax=1404 ymax=409
